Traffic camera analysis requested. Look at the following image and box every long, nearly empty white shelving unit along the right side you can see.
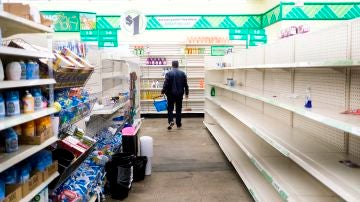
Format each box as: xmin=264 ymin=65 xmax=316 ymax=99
xmin=205 ymin=20 xmax=360 ymax=201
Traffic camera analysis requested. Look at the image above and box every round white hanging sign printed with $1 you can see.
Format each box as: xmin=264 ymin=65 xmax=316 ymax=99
xmin=120 ymin=10 xmax=147 ymax=36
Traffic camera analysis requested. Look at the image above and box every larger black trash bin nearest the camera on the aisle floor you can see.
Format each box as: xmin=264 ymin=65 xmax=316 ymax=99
xmin=106 ymin=153 xmax=135 ymax=200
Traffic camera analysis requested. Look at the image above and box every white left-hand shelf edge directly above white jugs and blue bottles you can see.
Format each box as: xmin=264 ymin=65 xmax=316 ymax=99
xmin=0 ymin=46 xmax=54 ymax=58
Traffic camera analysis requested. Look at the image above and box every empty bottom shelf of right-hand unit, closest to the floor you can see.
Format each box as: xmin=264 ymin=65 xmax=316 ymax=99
xmin=206 ymin=109 xmax=340 ymax=201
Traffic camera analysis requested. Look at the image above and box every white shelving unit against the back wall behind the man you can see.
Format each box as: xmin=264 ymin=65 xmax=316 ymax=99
xmin=134 ymin=43 xmax=210 ymax=114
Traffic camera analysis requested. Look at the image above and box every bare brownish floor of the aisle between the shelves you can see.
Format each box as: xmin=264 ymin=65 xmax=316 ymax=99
xmin=107 ymin=118 xmax=251 ymax=202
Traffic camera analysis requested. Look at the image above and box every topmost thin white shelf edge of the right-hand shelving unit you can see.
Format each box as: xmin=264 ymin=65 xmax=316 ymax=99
xmin=205 ymin=60 xmax=360 ymax=70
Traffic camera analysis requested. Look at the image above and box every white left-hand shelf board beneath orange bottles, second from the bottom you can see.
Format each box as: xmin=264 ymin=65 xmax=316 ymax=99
xmin=0 ymin=137 xmax=58 ymax=172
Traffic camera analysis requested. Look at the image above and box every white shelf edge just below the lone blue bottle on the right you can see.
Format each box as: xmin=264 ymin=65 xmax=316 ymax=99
xmin=209 ymin=83 xmax=360 ymax=136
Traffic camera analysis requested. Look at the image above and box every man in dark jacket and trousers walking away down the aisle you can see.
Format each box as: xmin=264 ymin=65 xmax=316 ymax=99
xmin=161 ymin=61 xmax=189 ymax=130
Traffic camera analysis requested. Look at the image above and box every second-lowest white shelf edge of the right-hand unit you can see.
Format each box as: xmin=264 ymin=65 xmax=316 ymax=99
xmin=206 ymin=97 xmax=356 ymax=201
